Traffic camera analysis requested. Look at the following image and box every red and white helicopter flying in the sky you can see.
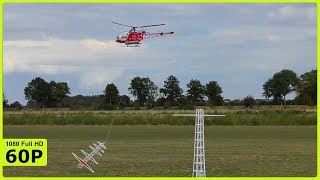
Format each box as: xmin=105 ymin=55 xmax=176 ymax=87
xmin=112 ymin=22 xmax=174 ymax=47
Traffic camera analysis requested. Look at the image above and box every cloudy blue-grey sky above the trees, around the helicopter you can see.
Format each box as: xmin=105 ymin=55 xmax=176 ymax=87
xmin=3 ymin=3 xmax=317 ymax=105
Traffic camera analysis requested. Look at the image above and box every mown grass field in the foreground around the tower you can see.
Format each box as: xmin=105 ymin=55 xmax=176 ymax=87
xmin=4 ymin=125 xmax=316 ymax=177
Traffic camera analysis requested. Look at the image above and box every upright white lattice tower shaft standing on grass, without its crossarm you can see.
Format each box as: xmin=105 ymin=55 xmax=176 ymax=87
xmin=192 ymin=109 xmax=206 ymax=177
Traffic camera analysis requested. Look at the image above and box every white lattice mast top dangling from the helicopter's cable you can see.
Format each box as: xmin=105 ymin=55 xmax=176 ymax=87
xmin=72 ymin=141 xmax=107 ymax=173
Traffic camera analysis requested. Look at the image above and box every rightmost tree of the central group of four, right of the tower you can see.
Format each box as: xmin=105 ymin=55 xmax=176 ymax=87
xmin=205 ymin=81 xmax=223 ymax=106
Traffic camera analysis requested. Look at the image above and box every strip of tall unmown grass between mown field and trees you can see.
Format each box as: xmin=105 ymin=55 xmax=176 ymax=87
xmin=3 ymin=110 xmax=317 ymax=126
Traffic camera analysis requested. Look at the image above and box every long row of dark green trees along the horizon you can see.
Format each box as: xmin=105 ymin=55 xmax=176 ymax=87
xmin=3 ymin=69 xmax=317 ymax=110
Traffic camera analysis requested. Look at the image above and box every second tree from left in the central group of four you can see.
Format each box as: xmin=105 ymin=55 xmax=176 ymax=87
xmin=160 ymin=75 xmax=183 ymax=105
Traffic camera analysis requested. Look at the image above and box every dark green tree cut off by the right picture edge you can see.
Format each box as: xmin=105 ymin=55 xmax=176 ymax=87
xmin=297 ymin=70 xmax=317 ymax=105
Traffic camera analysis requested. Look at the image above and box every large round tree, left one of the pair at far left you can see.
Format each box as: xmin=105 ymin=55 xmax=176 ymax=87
xmin=24 ymin=77 xmax=50 ymax=108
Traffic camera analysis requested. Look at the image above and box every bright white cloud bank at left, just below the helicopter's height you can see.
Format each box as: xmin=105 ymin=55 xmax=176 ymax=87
xmin=4 ymin=38 xmax=158 ymax=87
